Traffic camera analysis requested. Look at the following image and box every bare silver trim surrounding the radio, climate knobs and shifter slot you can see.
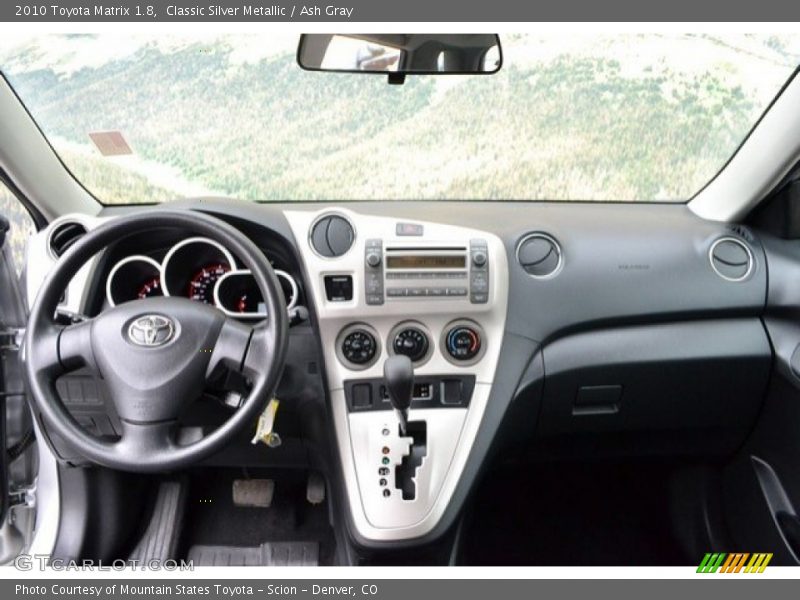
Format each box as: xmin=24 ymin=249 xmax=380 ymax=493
xmin=284 ymin=207 xmax=509 ymax=541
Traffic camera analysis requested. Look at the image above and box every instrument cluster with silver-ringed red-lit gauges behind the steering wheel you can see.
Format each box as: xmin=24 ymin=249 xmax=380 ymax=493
xmin=106 ymin=237 xmax=299 ymax=319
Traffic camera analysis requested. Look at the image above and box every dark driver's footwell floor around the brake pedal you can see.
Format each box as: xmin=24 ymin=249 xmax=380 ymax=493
xmin=181 ymin=469 xmax=335 ymax=565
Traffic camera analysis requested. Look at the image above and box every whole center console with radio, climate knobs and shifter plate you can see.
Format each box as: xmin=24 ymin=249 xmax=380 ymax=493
xmin=285 ymin=209 xmax=508 ymax=541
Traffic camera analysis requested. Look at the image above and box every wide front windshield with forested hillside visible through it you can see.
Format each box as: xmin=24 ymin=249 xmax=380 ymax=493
xmin=0 ymin=32 xmax=800 ymax=204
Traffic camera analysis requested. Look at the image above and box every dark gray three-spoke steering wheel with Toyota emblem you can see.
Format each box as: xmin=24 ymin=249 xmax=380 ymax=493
xmin=25 ymin=210 xmax=288 ymax=472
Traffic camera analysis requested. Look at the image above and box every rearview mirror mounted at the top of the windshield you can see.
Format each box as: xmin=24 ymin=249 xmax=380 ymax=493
xmin=297 ymin=33 xmax=503 ymax=82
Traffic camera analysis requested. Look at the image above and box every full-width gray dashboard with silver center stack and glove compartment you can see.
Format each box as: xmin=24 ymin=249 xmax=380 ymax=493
xmin=27 ymin=201 xmax=771 ymax=545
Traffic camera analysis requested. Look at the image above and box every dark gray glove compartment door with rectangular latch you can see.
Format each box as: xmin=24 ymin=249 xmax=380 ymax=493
xmin=537 ymin=318 xmax=771 ymax=455
